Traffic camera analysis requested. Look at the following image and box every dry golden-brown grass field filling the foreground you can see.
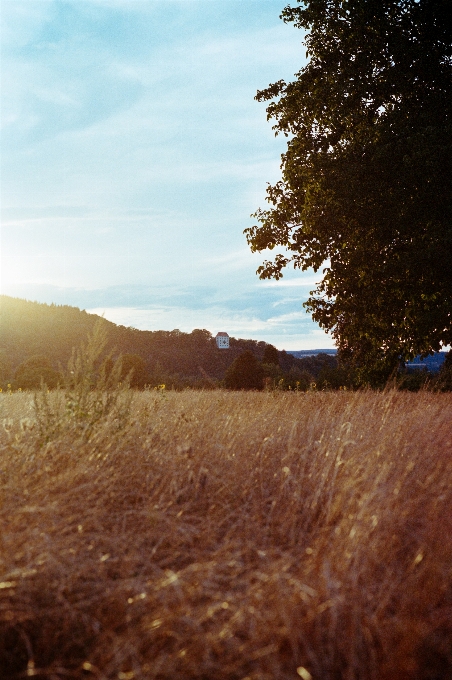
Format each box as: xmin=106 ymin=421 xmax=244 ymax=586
xmin=0 ymin=390 xmax=452 ymax=680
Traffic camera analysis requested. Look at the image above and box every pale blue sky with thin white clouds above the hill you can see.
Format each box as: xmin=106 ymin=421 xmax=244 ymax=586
xmin=0 ymin=0 xmax=334 ymax=350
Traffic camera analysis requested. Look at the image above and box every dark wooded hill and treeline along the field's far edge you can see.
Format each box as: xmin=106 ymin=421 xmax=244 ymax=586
xmin=0 ymin=295 xmax=452 ymax=391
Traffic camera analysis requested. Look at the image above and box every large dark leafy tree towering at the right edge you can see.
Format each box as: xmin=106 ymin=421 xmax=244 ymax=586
xmin=245 ymin=0 xmax=452 ymax=379
